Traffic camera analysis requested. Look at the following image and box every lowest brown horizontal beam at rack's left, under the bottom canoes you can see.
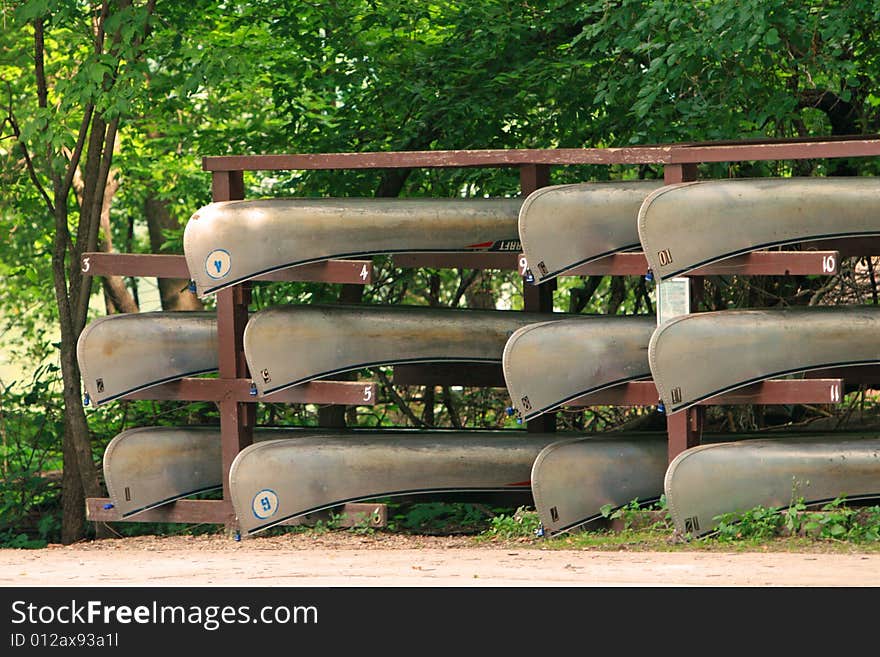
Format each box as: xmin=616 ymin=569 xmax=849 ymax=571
xmin=86 ymin=497 xmax=388 ymax=527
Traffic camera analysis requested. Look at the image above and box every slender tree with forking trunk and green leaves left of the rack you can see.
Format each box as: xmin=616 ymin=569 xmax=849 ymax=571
xmin=5 ymin=0 xmax=155 ymax=543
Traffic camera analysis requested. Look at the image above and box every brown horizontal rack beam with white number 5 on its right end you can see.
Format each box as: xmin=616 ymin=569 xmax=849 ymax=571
xmin=121 ymin=378 xmax=378 ymax=406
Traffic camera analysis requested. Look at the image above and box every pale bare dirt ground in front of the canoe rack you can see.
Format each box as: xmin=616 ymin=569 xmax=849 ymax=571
xmin=0 ymin=532 xmax=880 ymax=587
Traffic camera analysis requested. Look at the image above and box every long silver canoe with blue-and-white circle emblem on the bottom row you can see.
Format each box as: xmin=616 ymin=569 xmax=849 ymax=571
xmin=229 ymin=431 xmax=559 ymax=534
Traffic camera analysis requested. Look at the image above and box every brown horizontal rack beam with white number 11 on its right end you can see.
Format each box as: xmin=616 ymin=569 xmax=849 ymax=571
xmin=565 ymin=380 xmax=844 ymax=404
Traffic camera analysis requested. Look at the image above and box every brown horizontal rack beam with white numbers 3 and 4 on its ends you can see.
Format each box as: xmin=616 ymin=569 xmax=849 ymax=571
xmin=81 ymin=252 xmax=374 ymax=284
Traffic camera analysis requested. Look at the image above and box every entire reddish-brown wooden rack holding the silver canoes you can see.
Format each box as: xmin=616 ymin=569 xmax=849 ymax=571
xmin=81 ymin=137 xmax=880 ymax=531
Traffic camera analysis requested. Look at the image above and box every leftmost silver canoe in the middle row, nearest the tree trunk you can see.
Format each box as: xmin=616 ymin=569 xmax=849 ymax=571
xmin=76 ymin=311 xmax=218 ymax=405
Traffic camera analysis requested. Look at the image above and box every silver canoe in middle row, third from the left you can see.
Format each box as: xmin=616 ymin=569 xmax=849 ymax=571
xmin=502 ymin=315 xmax=657 ymax=420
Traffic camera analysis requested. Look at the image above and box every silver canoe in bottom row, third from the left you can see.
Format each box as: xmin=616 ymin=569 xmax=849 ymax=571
xmin=531 ymin=432 xmax=669 ymax=536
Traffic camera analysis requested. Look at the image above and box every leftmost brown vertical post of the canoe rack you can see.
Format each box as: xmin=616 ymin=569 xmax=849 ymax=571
xmin=211 ymin=171 xmax=256 ymax=533
